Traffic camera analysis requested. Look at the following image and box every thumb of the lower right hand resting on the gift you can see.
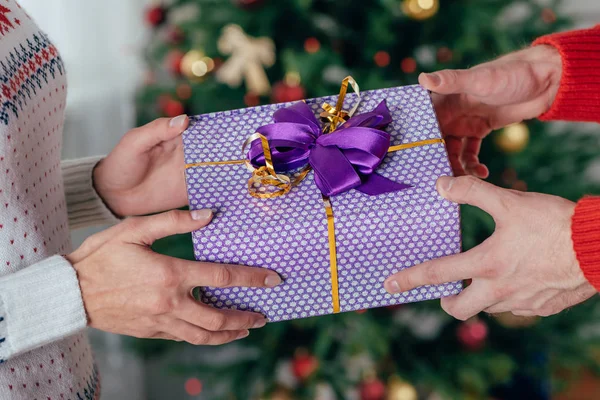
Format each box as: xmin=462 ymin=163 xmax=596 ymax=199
xmin=436 ymin=176 xmax=515 ymax=220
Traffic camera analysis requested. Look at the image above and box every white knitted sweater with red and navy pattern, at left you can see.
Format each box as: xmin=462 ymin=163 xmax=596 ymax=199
xmin=0 ymin=0 xmax=119 ymax=400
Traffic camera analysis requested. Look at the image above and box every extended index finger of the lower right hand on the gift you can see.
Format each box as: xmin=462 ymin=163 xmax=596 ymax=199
xmin=384 ymin=248 xmax=481 ymax=293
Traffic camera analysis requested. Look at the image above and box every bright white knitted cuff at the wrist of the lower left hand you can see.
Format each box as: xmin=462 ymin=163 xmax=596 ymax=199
xmin=0 ymin=256 xmax=87 ymax=361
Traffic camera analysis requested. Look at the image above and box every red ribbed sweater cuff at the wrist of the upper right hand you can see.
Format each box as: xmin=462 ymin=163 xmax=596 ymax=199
xmin=533 ymin=26 xmax=600 ymax=122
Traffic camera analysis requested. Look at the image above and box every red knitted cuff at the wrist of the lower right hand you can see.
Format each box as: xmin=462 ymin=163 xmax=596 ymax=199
xmin=571 ymin=197 xmax=600 ymax=291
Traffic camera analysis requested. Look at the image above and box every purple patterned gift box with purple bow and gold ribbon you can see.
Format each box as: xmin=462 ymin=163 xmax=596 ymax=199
xmin=183 ymin=80 xmax=462 ymax=322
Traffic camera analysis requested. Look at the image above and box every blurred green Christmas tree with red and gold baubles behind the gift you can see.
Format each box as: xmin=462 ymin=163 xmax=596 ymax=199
xmin=136 ymin=0 xmax=600 ymax=400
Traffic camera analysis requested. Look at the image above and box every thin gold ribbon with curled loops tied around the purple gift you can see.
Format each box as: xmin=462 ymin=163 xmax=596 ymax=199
xmin=185 ymin=76 xmax=444 ymax=314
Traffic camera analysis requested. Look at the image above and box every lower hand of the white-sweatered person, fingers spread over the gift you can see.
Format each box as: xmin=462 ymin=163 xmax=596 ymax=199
xmin=67 ymin=210 xmax=281 ymax=345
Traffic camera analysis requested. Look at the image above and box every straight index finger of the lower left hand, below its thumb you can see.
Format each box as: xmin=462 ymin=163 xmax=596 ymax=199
xmin=177 ymin=260 xmax=282 ymax=293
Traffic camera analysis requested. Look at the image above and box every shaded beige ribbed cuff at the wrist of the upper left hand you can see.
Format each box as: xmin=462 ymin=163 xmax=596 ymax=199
xmin=61 ymin=157 xmax=120 ymax=229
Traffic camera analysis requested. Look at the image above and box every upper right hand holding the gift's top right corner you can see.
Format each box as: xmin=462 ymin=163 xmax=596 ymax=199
xmin=419 ymin=45 xmax=562 ymax=178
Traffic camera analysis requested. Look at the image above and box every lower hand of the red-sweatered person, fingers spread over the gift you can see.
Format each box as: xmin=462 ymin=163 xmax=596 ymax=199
xmin=385 ymin=176 xmax=596 ymax=320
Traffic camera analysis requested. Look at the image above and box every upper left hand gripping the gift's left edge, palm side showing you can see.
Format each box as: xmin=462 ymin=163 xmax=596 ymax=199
xmin=94 ymin=115 xmax=189 ymax=217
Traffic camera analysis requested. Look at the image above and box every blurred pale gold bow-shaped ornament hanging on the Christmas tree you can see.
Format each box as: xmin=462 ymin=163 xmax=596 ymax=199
xmin=217 ymin=24 xmax=275 ymax=95
